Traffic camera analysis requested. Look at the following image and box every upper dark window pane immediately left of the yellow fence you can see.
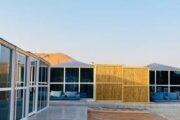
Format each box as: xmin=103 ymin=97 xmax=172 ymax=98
xmin=81 ymin=68 xmax=93 ymax=82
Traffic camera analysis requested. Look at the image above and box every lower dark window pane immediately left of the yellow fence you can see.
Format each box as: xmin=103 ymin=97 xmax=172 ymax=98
xmin=80 ymin=84 xmax=93 ymax=98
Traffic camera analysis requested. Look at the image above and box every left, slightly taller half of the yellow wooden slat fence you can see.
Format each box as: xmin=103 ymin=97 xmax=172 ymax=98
xmin=95 ymin=65 xmax=123 ymax=100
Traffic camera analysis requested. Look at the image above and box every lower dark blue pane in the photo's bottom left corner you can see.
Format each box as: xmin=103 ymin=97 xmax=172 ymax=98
xmin=0 ymin=91 xmax=10 ymax=120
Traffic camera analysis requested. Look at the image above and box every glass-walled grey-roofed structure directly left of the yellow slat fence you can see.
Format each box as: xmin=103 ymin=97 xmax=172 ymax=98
xmin=50 ymin=60 xmax=94 ymax=100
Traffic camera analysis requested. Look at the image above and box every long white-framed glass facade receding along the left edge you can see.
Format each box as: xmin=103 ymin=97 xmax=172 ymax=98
xmin=0 ymin=39 xmax=49 ymax=120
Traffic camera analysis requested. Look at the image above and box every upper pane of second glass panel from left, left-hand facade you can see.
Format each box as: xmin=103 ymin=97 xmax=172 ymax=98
xmin=16 ymin=54 xmax=26 ymax=87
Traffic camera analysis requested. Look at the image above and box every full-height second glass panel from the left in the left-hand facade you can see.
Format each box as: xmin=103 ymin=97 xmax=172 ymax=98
xmin=14 ymin=54 xmax=27 ymax=120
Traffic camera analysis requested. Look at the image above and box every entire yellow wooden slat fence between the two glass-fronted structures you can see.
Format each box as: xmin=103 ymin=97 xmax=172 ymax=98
xmin=95 ymin=65 xmax=149 ymax=102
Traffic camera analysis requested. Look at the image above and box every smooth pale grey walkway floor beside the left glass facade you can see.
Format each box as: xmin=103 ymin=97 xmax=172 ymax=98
xmin=28 ymin=106 xmax=87 ymax=120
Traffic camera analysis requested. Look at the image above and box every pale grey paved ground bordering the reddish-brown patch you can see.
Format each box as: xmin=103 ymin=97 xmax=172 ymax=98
xmin=29 ymin=101 xmax=180 ymax=120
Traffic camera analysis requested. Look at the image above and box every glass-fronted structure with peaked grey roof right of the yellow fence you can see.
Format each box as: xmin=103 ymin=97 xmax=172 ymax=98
xmin=149 ymin=63 xmax=180 ymax=102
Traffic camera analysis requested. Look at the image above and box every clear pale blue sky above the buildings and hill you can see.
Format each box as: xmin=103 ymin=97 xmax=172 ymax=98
xmin=0 ymin=0 xmax=180 ymax=67
